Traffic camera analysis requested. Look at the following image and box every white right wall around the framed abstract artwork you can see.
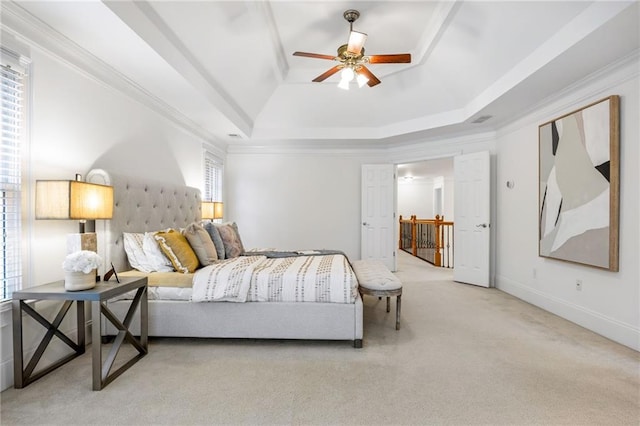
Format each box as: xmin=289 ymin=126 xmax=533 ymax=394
xmin=496 ymin=57 xmax=640 ymax=350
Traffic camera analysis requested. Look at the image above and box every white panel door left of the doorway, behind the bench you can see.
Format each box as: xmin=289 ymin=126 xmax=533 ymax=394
xmin=360 ymin=164 xmax=396 ymax=271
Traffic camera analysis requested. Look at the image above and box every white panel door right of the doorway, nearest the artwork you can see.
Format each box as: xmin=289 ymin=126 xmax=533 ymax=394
xmin=453 ymin=151 xmax=491 ymax=287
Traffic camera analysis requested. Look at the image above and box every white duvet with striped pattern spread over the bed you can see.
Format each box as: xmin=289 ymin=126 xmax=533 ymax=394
xmin=192 ymin=254 xmax=358 ymax=303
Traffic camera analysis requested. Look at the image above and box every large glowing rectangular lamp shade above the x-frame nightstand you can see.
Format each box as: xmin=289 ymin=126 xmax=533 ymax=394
xmin=36 ymin=180 xmax=113 ymax=220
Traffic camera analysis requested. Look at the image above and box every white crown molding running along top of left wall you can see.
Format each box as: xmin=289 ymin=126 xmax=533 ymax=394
xmin=2 ymin=1 xmax=226 ymax=149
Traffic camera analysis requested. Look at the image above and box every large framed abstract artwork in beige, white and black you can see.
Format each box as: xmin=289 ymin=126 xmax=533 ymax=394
xmin=538 ymin=95 xmax=620 ymax=271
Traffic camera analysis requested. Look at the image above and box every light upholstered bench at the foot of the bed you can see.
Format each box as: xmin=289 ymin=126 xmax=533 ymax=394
xmin=351 ymin=260 xmax=402 ymax=330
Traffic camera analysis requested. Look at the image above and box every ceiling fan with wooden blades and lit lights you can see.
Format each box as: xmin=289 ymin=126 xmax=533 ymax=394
xmin=293 ymin=9 xmax=411 ymax=89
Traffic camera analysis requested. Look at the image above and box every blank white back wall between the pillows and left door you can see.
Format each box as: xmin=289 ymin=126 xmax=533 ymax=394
xmin=225 ymin=153 xmax=362 ymax=259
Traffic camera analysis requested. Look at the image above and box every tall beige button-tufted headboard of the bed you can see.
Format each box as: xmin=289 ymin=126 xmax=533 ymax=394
xmin=86 ymin=169 xmax=201 ymax=271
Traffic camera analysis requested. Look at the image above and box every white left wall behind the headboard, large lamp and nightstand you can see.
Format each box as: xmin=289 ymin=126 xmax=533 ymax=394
xmin=0 ymin=42 xmax=210 ymax=389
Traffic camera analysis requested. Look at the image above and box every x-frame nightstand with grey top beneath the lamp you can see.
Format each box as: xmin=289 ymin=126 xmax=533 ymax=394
xmin=12 ymin=278 xmax=148 ymax=390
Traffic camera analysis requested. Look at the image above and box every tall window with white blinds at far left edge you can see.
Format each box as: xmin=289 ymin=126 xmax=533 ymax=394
xmin=0 ymin=48 xmax=25 ymax=300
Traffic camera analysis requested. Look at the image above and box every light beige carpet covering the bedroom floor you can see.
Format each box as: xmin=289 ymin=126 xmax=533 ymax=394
xmin=0 ymin=253 xmax=640 ymax=425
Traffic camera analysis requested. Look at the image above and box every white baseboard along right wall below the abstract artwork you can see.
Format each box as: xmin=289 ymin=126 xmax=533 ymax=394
xmin=496 ymin=275 xmax=640 ymax=351
